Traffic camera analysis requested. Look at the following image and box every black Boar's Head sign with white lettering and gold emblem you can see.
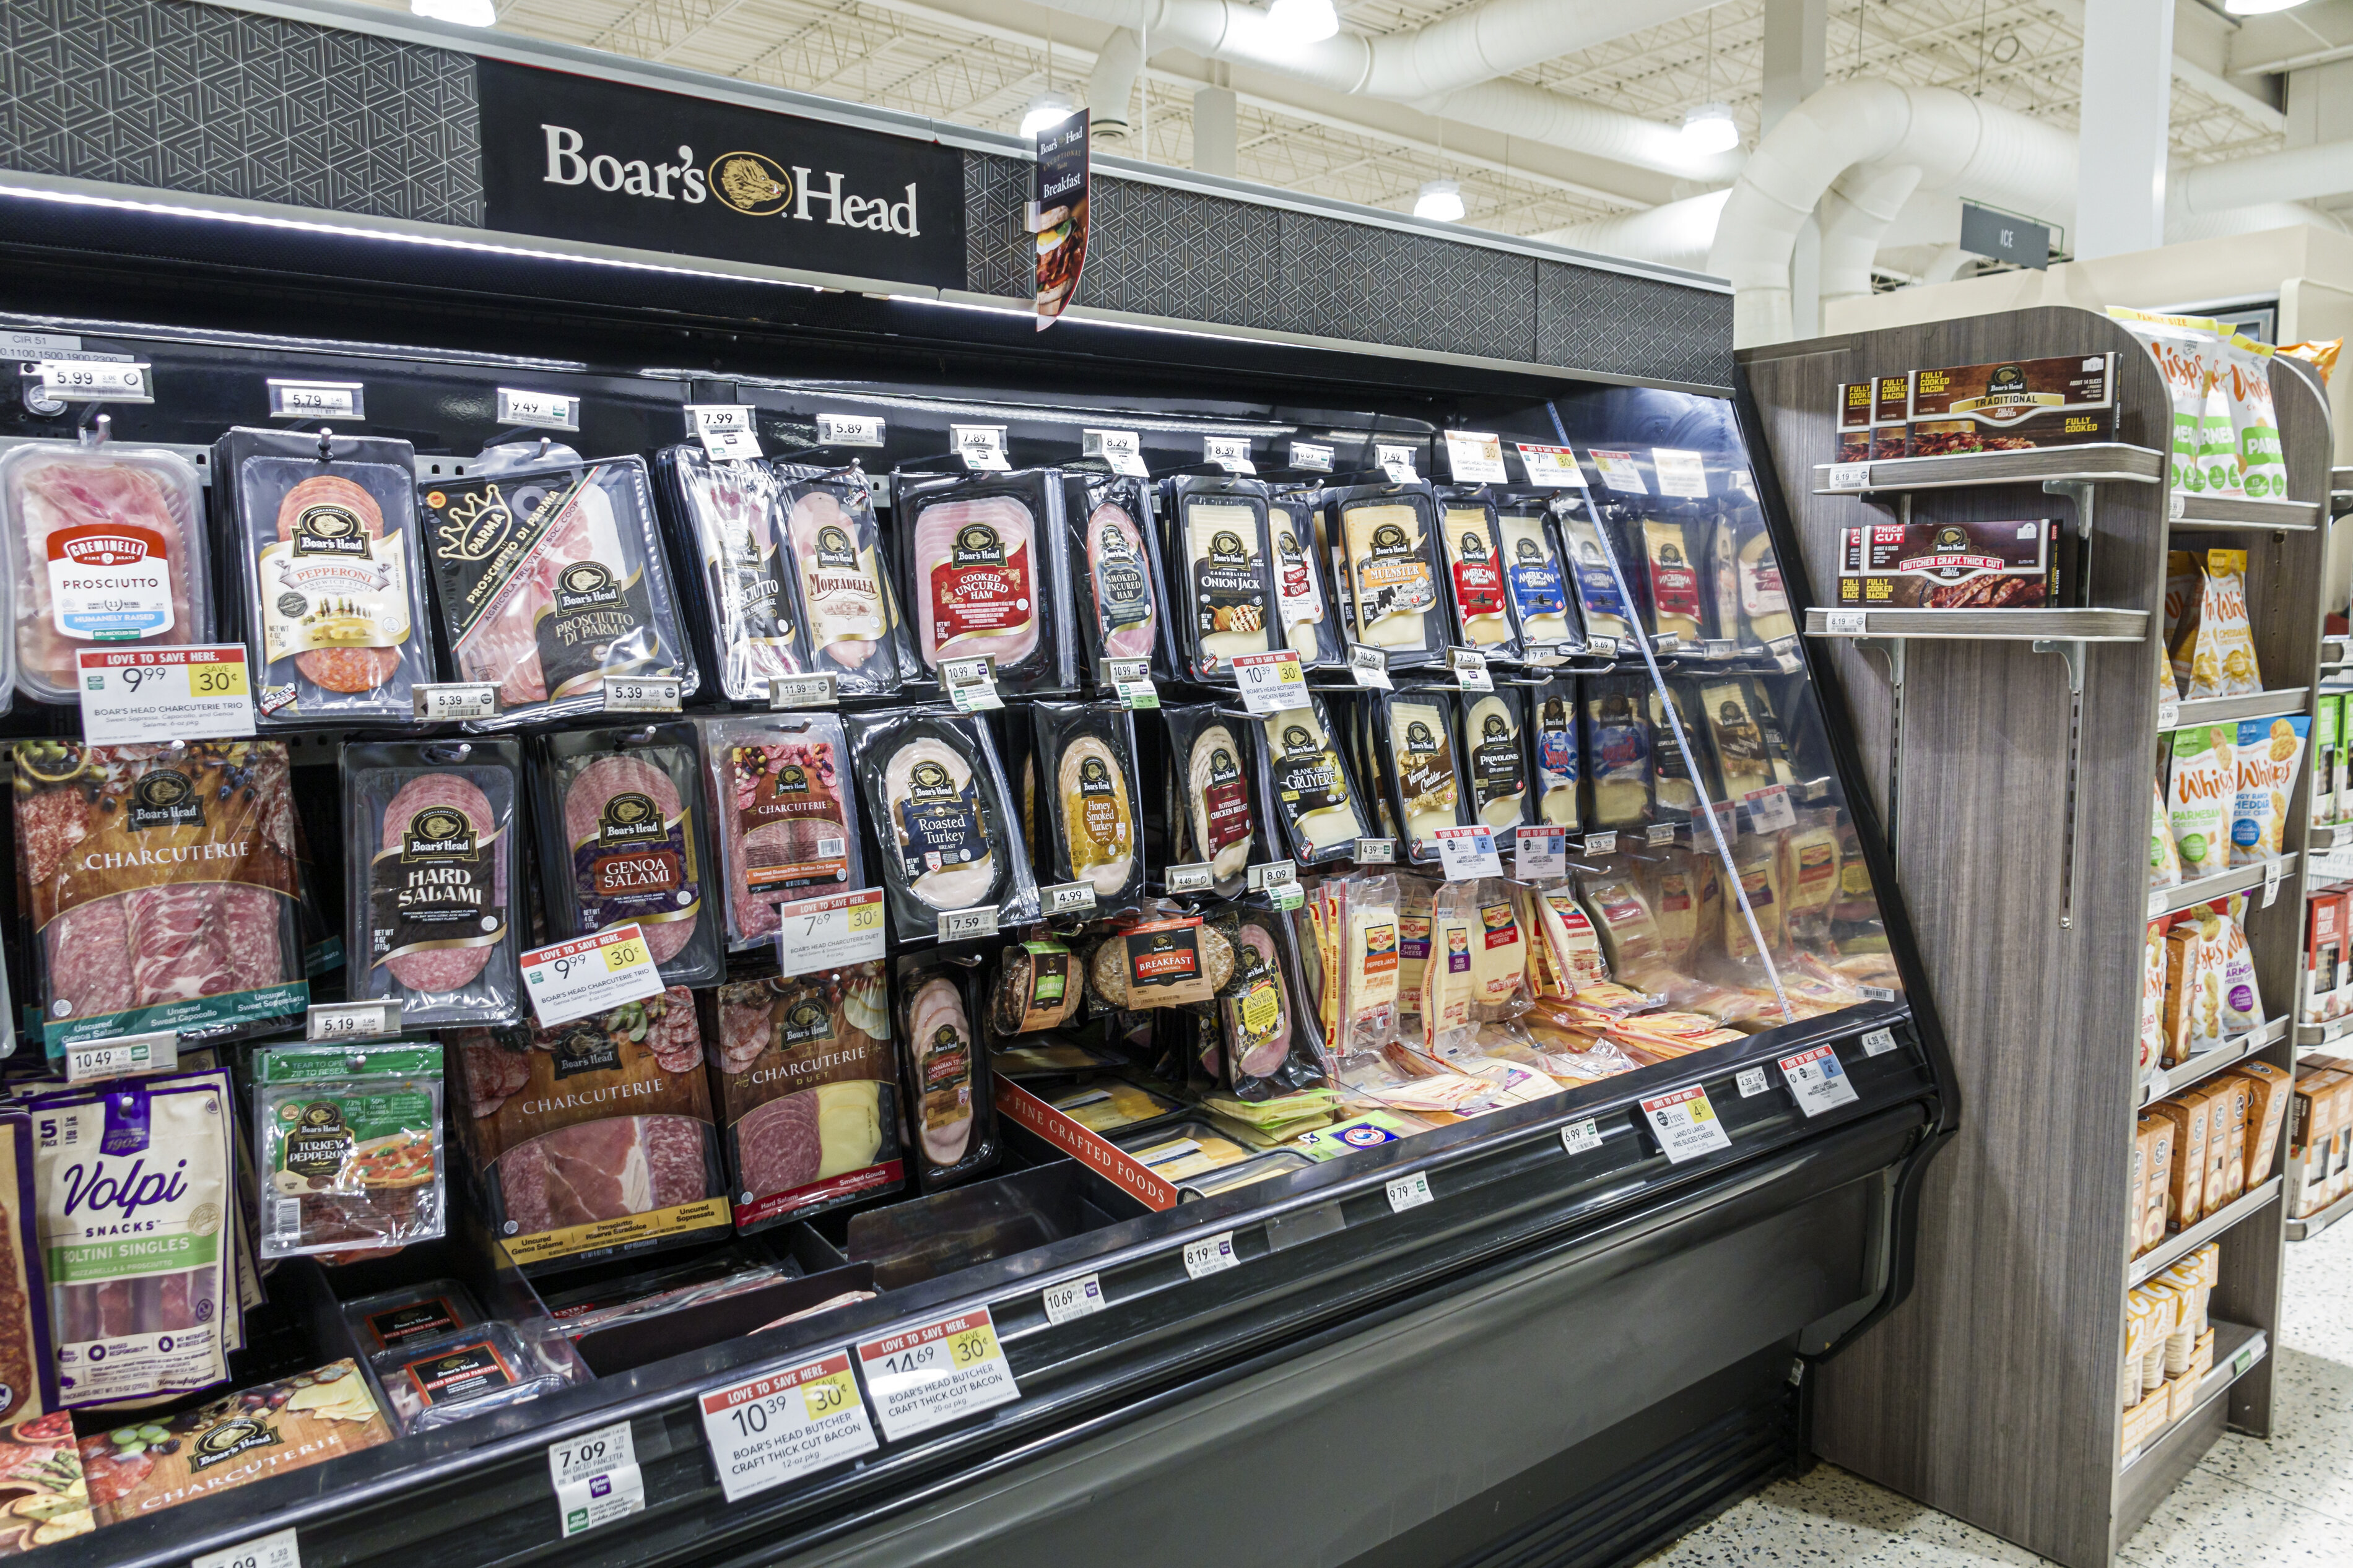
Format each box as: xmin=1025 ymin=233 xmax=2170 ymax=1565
xmin=476 ymin=59 xmax=965 ymax=289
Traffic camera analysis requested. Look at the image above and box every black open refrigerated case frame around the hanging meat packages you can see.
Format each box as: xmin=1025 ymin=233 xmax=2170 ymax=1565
xmin=0 ymin=193 xmax=1958 ymax=1568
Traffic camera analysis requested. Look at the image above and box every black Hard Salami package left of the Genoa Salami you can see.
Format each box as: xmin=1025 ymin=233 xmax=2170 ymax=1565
xmin=344 ymin=740 xmax=523 ymax=1028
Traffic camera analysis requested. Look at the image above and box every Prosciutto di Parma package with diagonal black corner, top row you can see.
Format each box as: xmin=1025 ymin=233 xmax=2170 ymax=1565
xmin=417 ymin=447 xmax=699 ymax=729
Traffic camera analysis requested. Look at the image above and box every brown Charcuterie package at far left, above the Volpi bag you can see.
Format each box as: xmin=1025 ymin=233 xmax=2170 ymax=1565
xmin=14 ymin=740 xmax=311 ymax=1055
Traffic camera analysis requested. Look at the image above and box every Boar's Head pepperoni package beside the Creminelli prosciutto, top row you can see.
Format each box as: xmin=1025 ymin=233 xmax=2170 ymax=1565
xmin=214 ymin=428 xmax=435 ymax=729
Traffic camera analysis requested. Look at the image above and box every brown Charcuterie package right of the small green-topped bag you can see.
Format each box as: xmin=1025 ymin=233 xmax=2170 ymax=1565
xmin=447 ymin=985 xmax=729 ymax=1270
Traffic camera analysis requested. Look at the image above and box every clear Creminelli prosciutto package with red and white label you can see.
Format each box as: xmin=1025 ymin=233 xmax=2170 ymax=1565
xmin=0 ymin=442 xmax=212 ymax=703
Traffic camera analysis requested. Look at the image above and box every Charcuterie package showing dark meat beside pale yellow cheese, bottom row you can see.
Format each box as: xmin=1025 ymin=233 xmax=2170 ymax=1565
xmin=711 ymin=959 xmax=906 ymax=1234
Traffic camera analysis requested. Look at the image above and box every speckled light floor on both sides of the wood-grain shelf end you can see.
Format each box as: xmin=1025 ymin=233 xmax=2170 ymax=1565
xmin=1642 ymin=1223 xmax=2353 ymax=1568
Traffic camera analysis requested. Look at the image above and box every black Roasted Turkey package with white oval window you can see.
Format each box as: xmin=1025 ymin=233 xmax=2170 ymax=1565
xmin=845 ymin=708 xmax=1038 ymax=938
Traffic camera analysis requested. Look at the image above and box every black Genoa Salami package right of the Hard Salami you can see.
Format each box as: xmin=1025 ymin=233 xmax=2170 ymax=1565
xmin=532 ymin=724 xmax=723 ymax=985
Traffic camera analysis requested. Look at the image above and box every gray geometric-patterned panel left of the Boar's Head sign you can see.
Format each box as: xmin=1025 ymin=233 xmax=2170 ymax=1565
xmin=0 ymin=0 xmax=482 ymax=228
